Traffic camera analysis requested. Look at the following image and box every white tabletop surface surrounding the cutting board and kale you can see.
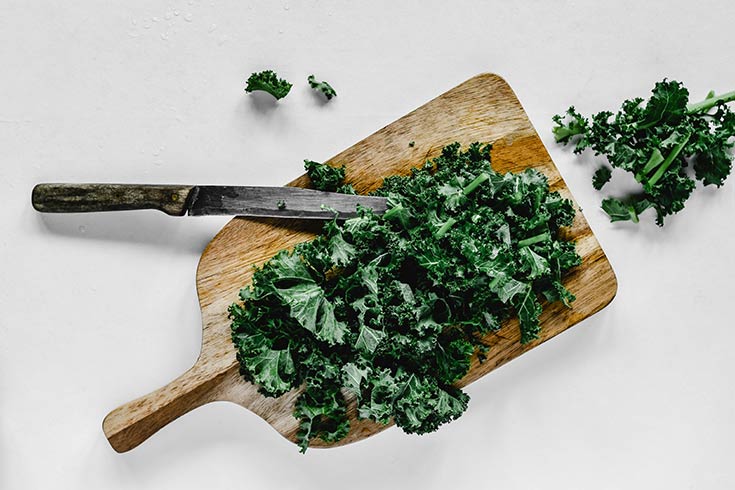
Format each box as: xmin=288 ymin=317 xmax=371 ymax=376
xmin=0 ymin=0 xmax=735 ymax=490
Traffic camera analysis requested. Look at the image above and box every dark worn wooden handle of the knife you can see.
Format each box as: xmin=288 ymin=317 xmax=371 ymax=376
xmin=31 ymin=184 xmax=194 ymax=216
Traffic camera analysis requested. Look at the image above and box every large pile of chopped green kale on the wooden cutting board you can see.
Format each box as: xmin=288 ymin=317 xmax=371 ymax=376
xmin=229 ymin=143 xmax=580 ymax=451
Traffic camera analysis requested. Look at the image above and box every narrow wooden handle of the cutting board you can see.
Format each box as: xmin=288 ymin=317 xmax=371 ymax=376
xmin=102 ymin=363 xmax=237 ymax=453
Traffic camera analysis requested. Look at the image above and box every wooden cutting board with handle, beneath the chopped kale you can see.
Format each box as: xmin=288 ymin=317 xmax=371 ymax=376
xmin=103 ymin=74 xmax=617 ymax=452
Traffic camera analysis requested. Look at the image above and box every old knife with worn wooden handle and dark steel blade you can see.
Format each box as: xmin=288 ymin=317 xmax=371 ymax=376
xmin=31 ymin=184 xmax=387 ymax=219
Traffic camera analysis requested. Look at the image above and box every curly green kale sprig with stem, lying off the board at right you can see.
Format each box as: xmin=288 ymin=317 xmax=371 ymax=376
xmin=553 ymin=79 xmax=735 ymax=226
